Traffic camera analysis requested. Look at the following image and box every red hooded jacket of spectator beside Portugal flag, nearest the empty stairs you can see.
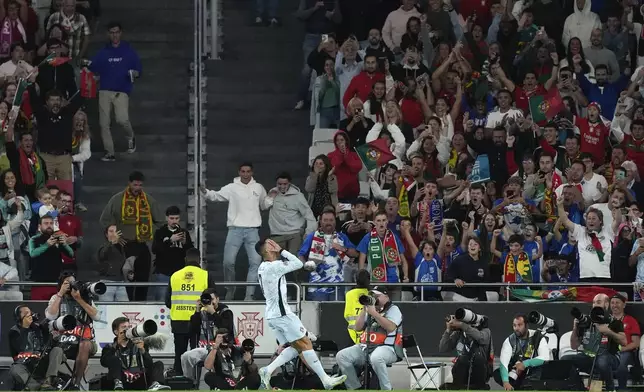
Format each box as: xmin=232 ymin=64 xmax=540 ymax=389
xmin=328 ymin=130 xmax=362 ymax=200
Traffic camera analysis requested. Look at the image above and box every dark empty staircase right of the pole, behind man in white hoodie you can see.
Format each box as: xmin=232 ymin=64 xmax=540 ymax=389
xmin=206 ymin=0 xmax=311 ymax=298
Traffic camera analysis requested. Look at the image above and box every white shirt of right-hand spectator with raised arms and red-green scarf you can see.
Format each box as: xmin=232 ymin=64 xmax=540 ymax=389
xmin=572 ymin=224 xmax=613 ymax=279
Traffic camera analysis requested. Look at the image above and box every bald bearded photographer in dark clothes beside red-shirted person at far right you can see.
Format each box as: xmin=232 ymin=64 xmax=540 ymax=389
xmin=562 ymin=294 xmax=627 ymax=391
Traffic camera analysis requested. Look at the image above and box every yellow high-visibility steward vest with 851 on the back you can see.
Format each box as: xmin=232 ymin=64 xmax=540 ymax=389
xmin=170 ymin=265 xmax=208 ymax=321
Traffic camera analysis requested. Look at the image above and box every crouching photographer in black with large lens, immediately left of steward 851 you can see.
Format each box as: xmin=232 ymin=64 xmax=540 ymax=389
xmin=101 ymin=317 xmax=170 ymax=391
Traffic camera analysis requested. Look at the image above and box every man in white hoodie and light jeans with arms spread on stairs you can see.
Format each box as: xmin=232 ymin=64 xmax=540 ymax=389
xmin=200 ymin=162 xmax=277 ymax=301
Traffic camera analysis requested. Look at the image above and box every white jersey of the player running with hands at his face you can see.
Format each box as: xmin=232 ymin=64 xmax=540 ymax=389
xmin=257 ymin=250 xmax=304 ymax=319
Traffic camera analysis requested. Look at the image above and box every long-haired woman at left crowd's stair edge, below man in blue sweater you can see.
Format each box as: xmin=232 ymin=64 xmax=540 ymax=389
xmin=72 ymin=110 xmax=92 ymax=212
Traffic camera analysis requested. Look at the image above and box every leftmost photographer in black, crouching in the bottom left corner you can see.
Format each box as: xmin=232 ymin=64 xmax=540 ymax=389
xmin=8 ymin=305 xmax=65 ymax=391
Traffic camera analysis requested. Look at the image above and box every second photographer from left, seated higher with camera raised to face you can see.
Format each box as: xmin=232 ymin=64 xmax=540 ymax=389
xmin=45 ymin=272 xmax=100 ymax=385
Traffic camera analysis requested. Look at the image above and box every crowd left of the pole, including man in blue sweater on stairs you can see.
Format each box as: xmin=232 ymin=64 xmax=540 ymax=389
xmin=0 ymin=0 xmax=184 ymax=301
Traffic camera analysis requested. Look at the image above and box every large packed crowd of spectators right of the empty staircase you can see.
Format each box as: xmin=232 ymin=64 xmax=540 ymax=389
xmin=220 ymin=0 xmax=644 ymax=301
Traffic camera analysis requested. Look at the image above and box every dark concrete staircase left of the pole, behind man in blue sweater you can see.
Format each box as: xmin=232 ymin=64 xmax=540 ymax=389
xmin=74 ymin=0 xmax=194 ymax=279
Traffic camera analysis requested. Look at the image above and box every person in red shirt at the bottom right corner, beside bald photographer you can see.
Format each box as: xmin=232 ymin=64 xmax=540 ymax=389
xmin=610 ymin=294 xmax=640 ymax=390
